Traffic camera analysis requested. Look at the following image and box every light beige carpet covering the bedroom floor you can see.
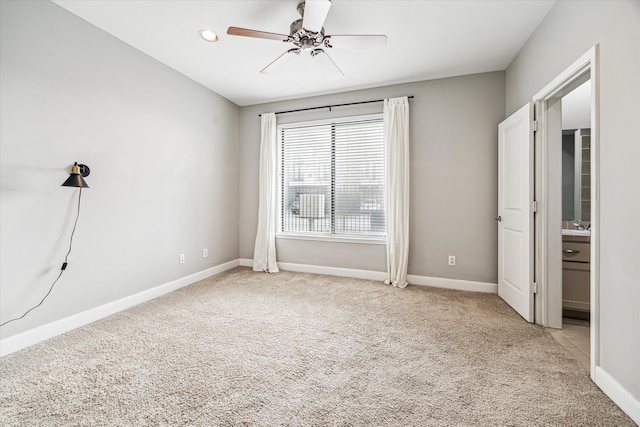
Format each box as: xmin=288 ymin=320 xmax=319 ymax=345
xmin=0 ymin=268 xmax=635 ymax=426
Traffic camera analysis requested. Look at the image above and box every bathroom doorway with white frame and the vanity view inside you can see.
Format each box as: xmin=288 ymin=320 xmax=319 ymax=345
xmin=533 ymin=46 xmax=599 ymax=376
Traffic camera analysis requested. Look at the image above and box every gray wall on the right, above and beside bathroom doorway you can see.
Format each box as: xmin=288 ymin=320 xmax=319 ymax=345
xmin=506 ymin=1 xmax=640 ymax=401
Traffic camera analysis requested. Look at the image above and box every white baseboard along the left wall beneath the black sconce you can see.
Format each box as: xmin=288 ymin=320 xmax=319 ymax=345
xmin=0 ymin=259 xmax=239 ymax=356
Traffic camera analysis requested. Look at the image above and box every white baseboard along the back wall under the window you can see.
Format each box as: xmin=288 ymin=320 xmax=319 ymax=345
xmin=240 ymin=258 xmax=498 ymax=294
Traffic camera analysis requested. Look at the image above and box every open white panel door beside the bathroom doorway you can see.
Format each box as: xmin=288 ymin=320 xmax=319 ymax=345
xmin=496 ymin=103 xmax=534 ymax=322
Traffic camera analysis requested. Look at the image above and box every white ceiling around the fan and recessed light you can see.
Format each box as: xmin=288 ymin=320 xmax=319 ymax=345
xmin=53 ymin=0 xmax=555 ymax=106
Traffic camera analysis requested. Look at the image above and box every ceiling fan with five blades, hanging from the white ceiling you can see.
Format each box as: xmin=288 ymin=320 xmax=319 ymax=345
xmin=227 ymin=0 xmax=387 ymax=80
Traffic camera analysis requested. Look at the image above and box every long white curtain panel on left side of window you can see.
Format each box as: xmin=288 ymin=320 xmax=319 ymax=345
xmin=253 ymin=113 xmax=279 ymax=273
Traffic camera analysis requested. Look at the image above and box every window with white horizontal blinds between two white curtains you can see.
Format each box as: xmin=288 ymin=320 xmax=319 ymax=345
xmin=278 ymin=114 xmax=385 ymax=238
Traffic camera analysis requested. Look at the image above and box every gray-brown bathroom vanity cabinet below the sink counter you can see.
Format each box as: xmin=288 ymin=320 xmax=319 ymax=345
xmin=562 ymin=236 xmax=591 ymax=314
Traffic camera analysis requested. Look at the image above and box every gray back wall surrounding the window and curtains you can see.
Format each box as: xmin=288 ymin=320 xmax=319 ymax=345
xmin=239 ymin=72 xmax=504 ymax=283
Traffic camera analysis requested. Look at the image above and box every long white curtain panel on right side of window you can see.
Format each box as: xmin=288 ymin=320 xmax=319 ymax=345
xmin=384 ymin=96 xmax=409 ymax=288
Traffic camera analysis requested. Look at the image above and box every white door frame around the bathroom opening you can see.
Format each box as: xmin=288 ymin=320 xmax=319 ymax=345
xmin=532 ymin=45 xmax=600 ymax=378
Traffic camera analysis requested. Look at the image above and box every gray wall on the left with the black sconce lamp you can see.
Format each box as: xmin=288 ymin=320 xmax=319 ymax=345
xmin=0 ymin=1 xmax=239 ymax=338
